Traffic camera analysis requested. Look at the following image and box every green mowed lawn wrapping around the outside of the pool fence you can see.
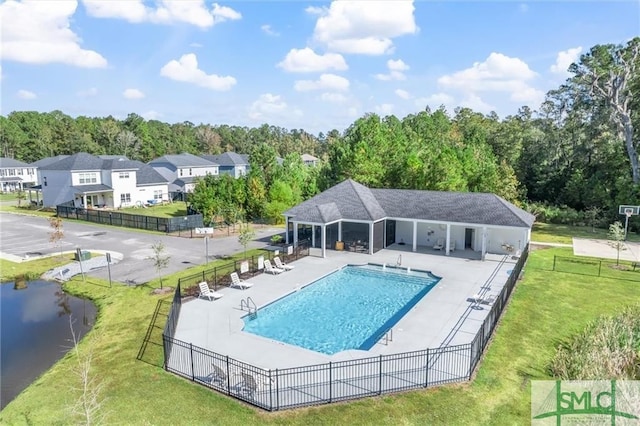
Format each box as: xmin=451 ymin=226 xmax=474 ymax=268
xmin=0 ymin=248 xmax=640 ymax=425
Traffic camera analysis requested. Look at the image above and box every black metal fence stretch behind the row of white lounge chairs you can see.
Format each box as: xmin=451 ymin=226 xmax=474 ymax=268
xmin=178 ymin=240 xmax=310 ymax=298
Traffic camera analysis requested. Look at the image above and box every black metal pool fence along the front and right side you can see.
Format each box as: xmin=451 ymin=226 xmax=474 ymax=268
xmin=163 ymin=248 xmax=528 ymax=411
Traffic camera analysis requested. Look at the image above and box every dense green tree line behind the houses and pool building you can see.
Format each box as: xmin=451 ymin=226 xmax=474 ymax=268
xmin=0 ymin=37 xmax=640 ymax=228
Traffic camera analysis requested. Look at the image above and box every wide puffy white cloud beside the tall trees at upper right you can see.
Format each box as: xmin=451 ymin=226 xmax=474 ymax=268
xmin=438 ymin=52 xmax=544 ymax=102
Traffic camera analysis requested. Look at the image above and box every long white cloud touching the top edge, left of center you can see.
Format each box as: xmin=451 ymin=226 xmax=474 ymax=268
xmin=82 ymin=0 xmax=242 ymax=28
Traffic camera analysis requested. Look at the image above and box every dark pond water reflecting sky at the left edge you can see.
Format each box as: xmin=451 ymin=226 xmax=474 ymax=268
xmin=0 ymin=281 xmax=96 ymax=410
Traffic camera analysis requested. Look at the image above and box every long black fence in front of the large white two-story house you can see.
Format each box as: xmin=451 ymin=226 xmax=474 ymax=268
xmin=56 ymin=204 xmax=203 ymax=233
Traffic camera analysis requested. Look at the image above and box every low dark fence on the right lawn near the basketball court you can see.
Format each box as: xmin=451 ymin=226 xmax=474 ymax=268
xmin=552 ymin=256 xmax=640 ymax=281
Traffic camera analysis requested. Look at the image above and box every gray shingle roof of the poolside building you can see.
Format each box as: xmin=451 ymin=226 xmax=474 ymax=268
xmin=284 ymin=180 xmax=535 ymax=228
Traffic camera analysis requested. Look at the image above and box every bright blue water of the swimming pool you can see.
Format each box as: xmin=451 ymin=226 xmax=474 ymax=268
xmin=243 ymin=265 xmax=440 ymax=355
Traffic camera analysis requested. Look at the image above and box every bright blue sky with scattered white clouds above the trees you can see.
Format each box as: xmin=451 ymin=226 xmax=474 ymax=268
xmin=0 ymin=0 xmax=640 ymax=133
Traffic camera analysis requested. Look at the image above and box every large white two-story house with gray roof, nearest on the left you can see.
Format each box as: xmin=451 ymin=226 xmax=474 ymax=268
xmin=40 ymin=152 xmax=169 ymax=208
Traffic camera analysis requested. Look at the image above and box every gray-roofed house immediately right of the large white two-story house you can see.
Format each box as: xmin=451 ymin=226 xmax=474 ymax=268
xmin=149 ymin=153 xmax=219 ymax=193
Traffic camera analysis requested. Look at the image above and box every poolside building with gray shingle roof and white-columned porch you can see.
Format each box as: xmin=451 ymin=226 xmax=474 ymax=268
xmin=283 ymin=179 xmax=535 ymax=259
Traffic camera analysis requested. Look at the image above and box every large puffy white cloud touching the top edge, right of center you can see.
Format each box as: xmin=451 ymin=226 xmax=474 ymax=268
xmin=313 ymin=0 xmax=418 ymax=55
